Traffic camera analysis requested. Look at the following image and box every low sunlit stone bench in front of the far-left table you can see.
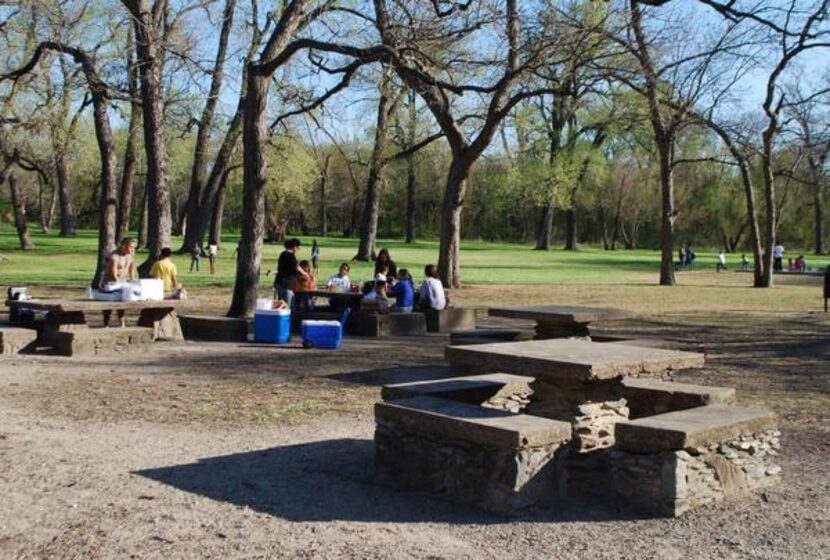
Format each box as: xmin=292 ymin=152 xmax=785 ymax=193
xmin=53 ymin=327 xmax=154 ymax=356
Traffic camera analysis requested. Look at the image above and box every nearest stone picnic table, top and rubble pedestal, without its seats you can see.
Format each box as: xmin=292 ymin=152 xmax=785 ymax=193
xmin=445 ymin=338 xmax=704 ymax=452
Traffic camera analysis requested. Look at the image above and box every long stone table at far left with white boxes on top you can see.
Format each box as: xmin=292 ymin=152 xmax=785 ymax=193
xmin=6 ymin=299 xmax=192 ymax=344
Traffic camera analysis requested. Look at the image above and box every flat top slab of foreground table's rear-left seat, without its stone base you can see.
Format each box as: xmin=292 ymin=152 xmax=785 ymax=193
xmin=381 ymin=373 xmax=533 ymax=404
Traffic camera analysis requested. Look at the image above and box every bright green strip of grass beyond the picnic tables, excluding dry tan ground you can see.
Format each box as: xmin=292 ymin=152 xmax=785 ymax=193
xmin=0 ymin=225 xmax=830 ymax=288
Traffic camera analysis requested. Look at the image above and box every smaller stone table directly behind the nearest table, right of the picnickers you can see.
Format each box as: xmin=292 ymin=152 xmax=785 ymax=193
xmin=488 ymin=305 xmax=625 ymax=339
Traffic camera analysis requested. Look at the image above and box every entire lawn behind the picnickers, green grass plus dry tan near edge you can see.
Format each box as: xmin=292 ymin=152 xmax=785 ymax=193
xmin=0 ymin=225 xmax=830 ymax=314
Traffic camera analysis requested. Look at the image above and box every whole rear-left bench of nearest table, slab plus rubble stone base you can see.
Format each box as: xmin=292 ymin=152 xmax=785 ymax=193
xmin=380 ymin=373 xmax=533 ymax=413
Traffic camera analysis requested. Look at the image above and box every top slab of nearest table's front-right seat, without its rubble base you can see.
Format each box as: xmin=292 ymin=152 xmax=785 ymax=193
xmin=616 ymin=405 xmax=777 ymax=453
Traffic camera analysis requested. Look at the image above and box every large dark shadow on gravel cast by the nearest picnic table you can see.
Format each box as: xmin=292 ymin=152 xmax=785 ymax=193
xmin=133 ymin=439 xmax=638 ymax=524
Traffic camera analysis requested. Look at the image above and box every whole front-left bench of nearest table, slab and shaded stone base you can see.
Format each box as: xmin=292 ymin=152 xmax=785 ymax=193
xmin=375 ymin=397 xmax=571 ymax=513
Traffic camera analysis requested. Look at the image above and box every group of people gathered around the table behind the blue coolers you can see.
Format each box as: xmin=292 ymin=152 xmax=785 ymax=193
xmin=274 ymin=238 xmax=447 ymax=313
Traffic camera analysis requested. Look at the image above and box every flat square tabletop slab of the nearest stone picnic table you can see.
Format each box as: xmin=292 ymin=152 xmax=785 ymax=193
xmin=445 ymin=339 xmax=704 ymax=382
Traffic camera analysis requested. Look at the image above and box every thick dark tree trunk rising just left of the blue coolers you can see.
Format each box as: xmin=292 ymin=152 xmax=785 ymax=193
xmin=228 ymin=74 xmax=271 ymax=317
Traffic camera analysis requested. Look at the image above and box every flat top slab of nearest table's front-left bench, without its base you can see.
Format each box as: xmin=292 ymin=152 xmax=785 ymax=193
xmin=375 ymin=397 xmax=571 ymax=450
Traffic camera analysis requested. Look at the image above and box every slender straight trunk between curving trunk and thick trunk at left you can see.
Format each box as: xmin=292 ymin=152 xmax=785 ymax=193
xmin=115 ymin=26 xmax=141 ymax=242
